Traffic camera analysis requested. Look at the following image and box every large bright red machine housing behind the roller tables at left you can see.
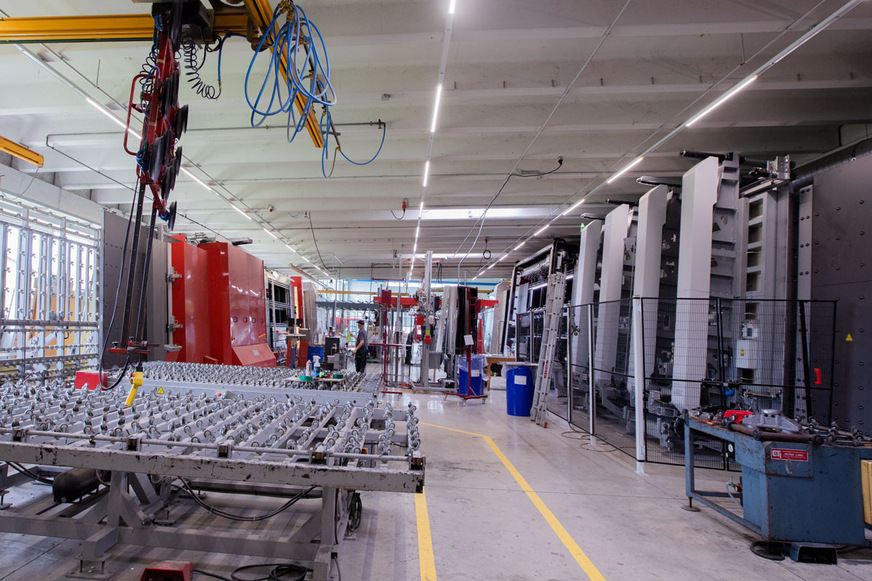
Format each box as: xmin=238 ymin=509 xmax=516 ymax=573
xmin=167 ymin=241 xmax=276 ymax=367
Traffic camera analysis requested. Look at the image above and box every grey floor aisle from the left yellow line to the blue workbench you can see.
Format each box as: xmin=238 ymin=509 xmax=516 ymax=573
xmin=358 ymin=386 xmax=872 ymax=581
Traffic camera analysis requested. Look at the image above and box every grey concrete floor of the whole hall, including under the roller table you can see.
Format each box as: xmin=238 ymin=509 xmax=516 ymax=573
xmin=0 ymin=378 xmax=872 ymax=581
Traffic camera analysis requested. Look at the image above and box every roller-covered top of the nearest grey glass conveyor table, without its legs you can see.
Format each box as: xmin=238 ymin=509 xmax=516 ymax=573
xmin=0 ymin=382 xmax=423 ymax=487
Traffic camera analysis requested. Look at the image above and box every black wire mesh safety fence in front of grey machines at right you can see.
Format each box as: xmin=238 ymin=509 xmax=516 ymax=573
xmin=549 ymin=298 xmax=836 ymax=470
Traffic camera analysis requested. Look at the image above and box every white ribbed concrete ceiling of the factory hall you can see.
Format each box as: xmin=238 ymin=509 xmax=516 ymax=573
xmin=0 ymin=0 xmax=872 ymax=278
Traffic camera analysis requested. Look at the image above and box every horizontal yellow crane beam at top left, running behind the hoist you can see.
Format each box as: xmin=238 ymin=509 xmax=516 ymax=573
xmin=0 ymin=10 xmax=248 ymax=44
